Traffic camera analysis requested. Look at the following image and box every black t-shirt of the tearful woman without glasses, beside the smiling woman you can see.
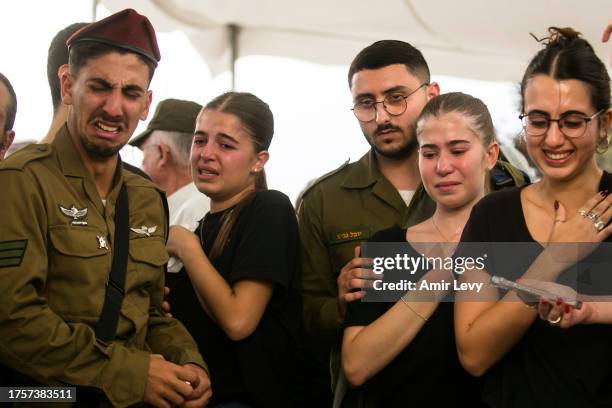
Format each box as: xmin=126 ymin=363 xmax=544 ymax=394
xmin=342 ymin=226 xmax=482 ymax=407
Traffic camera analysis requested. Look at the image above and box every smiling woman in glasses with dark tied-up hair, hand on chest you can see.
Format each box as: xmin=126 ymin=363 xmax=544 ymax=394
xmin=455 ymin=28 xmax=612 ymax=408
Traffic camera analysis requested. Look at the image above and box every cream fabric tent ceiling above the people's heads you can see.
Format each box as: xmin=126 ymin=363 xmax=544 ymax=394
xmin=101 ymin=0 xmax=612 ymax=81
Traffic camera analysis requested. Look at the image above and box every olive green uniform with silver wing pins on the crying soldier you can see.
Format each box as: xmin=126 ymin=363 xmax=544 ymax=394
xmin=0 ymin=127 xmax=205 ymax=406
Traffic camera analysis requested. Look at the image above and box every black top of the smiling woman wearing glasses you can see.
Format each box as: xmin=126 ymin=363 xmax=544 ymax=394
xmin=461 ymin=173 xmax=612 ymax=408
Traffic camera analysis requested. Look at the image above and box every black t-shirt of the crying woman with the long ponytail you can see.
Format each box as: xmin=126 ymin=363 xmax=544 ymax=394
xmin=167 ymin=190 xmax=302 ymax=407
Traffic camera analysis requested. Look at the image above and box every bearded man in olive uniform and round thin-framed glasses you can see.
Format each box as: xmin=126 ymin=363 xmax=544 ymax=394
xmin=298 ymin=40 xmax=525 ymax=406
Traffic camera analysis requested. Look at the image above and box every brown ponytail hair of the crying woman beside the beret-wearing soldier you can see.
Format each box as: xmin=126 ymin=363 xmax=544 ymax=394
xmin=203 ymin=92 xmax=274 ymax=259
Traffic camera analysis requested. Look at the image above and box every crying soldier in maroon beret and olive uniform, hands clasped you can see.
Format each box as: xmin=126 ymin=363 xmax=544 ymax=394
xmin=0 ymin=10 xmax=211 ymax=407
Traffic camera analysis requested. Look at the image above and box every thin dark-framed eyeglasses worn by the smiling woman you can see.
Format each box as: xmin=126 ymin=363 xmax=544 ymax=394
xmin=519 ymin=108 xmax=608 ymax=138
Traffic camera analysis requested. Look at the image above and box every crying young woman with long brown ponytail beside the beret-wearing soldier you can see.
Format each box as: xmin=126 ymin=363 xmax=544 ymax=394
xmin=167 ymin=92 xmax=302 ymax=407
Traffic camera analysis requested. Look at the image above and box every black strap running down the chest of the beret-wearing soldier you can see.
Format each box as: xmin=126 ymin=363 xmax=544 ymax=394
xmin=95 ymin=184 xmax=130 ymax=342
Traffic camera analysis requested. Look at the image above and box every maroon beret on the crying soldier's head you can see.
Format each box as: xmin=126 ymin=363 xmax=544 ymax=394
xmin=66 ymin=9 xmax=161 ymax=66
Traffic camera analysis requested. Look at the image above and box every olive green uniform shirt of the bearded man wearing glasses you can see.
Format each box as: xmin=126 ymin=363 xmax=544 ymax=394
xmin=298 ymin=150 xmax=524 ymax=402
